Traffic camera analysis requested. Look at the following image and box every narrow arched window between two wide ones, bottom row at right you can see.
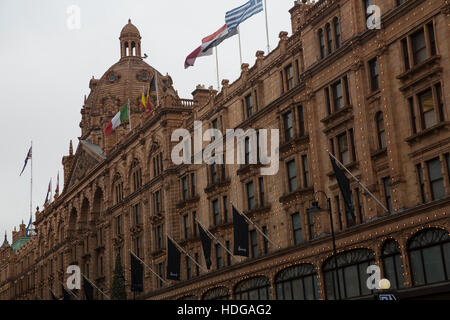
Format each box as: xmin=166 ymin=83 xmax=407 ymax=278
xmin=381 ymin=240 xmax=405 ymax=289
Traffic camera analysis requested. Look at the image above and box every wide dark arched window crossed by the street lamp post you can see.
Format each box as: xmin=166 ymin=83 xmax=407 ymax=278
xmin=323 ymin=249 xmax=375 ymax=300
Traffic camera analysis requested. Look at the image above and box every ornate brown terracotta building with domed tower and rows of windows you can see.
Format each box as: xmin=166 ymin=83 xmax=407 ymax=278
xmin=0 ymin=0 xmax=450 ymax=299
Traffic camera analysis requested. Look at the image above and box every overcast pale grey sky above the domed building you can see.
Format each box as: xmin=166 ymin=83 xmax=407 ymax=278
xmin=0 ymin=0 xmax=294 ymax=240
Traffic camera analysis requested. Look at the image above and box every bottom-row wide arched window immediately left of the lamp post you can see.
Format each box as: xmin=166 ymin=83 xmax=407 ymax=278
xmin=275 ymin=264 xmax=320 ymax=300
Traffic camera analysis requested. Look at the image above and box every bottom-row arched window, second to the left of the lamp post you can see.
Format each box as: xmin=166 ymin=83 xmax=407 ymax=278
xmin=234 ymin=277 xmax=271 ymax=300
